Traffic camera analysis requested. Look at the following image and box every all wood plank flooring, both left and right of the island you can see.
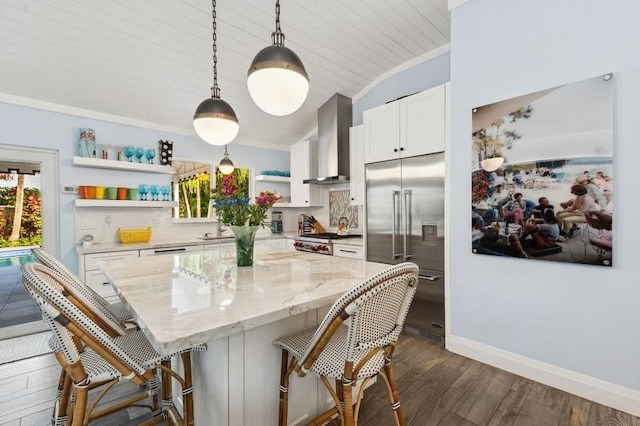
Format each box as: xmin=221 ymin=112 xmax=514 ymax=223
xmin=0 ymin=334 xmax=640 ymax=426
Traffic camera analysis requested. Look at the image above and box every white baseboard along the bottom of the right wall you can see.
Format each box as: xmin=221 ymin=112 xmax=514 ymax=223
xmin=447 ymin=336 xmax=640 ymax=416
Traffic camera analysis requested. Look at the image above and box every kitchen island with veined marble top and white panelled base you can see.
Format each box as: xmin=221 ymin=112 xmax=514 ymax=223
xmin=101 ymin=247 xmax=388 ymax=426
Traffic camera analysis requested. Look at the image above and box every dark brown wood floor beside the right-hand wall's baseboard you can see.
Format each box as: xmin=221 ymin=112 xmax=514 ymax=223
xmin=359 ymin=333 xmax=640 ymax=426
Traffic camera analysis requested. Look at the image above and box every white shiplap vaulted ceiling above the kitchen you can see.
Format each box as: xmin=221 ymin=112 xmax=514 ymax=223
xmin=0 ymin=0 xmax=450 ymax=149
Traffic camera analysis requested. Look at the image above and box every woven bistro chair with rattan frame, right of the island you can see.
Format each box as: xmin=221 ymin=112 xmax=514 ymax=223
xmin=274 ymin=262 xmax=418 ymax=426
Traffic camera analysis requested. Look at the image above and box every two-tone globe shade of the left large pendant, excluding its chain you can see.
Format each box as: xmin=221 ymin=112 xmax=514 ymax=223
xmin=193 ymin=97 xmax=240 ymax=145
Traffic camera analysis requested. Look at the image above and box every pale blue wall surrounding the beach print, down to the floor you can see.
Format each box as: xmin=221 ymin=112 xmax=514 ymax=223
xmin=447 ymin=0 xmax=640 ymax=415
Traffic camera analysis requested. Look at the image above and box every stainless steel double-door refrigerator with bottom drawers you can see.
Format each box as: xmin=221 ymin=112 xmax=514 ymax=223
xmin=365 ymin=153 xmax=444 ymax=340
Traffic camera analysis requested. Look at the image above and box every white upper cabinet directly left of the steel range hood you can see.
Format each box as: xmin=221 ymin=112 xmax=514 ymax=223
xmin=291 ymin=141 xmax=322 ymax=207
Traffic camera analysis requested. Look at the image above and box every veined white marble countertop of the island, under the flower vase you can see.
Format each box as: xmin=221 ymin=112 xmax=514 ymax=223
xmin=101 ymin=247 xmax=389 ymax=354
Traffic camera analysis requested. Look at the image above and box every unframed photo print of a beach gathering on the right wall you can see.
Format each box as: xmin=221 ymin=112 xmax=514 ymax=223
xmin=471 ymin=74 xmax=614 ymax=266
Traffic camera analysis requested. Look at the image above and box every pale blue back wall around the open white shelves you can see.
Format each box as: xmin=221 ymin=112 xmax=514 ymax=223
xmin=0 ymin=99 xmax=289 ymax=270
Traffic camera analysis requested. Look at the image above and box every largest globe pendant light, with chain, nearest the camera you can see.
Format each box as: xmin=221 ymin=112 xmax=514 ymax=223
xmin=247 ymin=0 xmax=309 ymax=116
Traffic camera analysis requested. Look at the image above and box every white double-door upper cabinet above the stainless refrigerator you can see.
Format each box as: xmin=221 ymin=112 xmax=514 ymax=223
xmin=363 ymin=85 xmax=446 ymax=163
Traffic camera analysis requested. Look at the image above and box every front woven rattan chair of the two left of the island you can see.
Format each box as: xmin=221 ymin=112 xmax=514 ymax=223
xmin=21 ymin=263 xmax=202 ymax=425
